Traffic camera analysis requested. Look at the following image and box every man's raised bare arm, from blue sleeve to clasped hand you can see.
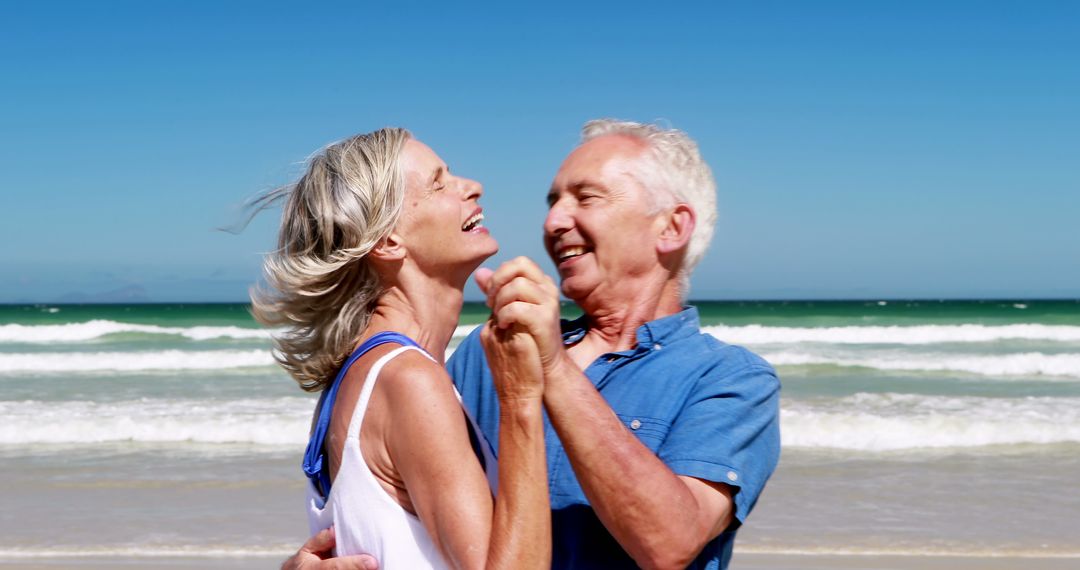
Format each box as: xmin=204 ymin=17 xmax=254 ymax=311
xmin=477 ymin=258 xmax=733 ymax=568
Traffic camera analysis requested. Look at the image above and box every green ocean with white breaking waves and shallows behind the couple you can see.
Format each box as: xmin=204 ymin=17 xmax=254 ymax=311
xmin=0 ymin=300 xmax=1080 ymax=567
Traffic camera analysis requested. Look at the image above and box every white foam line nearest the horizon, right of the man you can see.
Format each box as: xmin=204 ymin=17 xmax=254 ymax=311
xmin=703 ymin=324 xmax=1080 ymax=345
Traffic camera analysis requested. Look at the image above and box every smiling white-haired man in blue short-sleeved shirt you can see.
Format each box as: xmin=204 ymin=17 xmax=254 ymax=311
xmin=294 ymin=120 xmax=780 ymax=568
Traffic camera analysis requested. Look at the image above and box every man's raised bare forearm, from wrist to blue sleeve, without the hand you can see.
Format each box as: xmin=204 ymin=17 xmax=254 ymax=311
xmin=544 ymin=359 xmax=730 ymax=568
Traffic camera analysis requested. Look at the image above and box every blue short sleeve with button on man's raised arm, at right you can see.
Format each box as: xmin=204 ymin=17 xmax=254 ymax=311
xmin=659 ymin=361 xmax=780 ymax=523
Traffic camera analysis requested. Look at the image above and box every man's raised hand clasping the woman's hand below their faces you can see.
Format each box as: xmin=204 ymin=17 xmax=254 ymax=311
xmin=476 ymin=257 xmax=565 ymax=372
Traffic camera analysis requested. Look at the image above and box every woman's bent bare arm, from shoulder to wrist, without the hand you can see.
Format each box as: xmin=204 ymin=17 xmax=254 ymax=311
xmin=379 ymin=347 xmax=551 ymax=569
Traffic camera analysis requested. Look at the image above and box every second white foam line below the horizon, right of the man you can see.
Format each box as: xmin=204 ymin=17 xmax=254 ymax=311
xmin=761 ymin=351 xmax=1080 ymax=379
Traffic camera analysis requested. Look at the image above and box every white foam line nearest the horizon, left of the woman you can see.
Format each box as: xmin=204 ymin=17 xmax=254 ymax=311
xmin=0 ymin=320 xmax=271 ymax=343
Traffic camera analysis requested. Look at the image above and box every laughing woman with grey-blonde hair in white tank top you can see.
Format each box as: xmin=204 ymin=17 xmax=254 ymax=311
xmin=253 ymin=128 xmax=551 ymax=570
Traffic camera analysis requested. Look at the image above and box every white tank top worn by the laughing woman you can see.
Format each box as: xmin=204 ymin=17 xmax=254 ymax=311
xmin=307 ymin=347 xmax=498 ymax=570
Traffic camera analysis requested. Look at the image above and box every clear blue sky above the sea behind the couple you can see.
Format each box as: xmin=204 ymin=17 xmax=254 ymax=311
xmin=0 ymin=1 xmax=1080 ymax=302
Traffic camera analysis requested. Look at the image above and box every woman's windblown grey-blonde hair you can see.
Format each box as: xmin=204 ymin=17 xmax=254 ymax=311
xmin=252 ymin=128 xmax=410 ymax=392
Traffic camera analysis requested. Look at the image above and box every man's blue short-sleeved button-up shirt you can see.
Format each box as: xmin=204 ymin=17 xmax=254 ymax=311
xmin=447 ymin=307 xmax=780 ymax=569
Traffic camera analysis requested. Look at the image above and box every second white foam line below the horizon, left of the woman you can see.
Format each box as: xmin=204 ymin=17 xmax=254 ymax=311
xmin=0 ymin=349 xmax=275 ymax=375
